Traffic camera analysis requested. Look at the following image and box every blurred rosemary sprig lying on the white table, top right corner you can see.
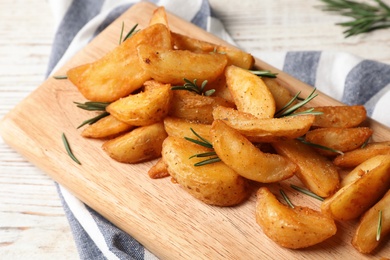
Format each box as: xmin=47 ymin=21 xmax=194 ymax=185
xmin=320 ymin=0 xmax=390 ymax=38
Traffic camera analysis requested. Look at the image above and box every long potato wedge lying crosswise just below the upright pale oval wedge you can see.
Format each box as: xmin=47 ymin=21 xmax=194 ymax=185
xmin=213 ymin=106 xmax=315 ymax=142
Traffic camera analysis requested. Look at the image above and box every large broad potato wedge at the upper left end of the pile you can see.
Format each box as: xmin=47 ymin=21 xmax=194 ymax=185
xmin=67 ymin=24 xmax=172 ymax=102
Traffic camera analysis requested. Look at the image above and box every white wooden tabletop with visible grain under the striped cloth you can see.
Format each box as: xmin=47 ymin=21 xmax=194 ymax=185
xmin=0 ymin=0 xmax=390 ymax=259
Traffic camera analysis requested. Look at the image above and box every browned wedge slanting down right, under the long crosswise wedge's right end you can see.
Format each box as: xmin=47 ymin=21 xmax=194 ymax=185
xmin=272 ymin=140 xmax=340 ymax=197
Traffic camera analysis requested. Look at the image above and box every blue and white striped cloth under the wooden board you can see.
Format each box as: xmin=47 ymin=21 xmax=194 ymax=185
xmin=48 ymin=0 xmax=390 ymax=259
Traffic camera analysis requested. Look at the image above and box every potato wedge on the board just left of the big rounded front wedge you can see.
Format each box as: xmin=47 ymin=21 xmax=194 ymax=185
xmin=102 ymin=123 xmax=168 ymax=163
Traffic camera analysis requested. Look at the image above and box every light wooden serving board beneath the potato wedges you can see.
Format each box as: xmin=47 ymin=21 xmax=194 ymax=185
xmin=0 ymin=2 xmax=390 ymax=259
